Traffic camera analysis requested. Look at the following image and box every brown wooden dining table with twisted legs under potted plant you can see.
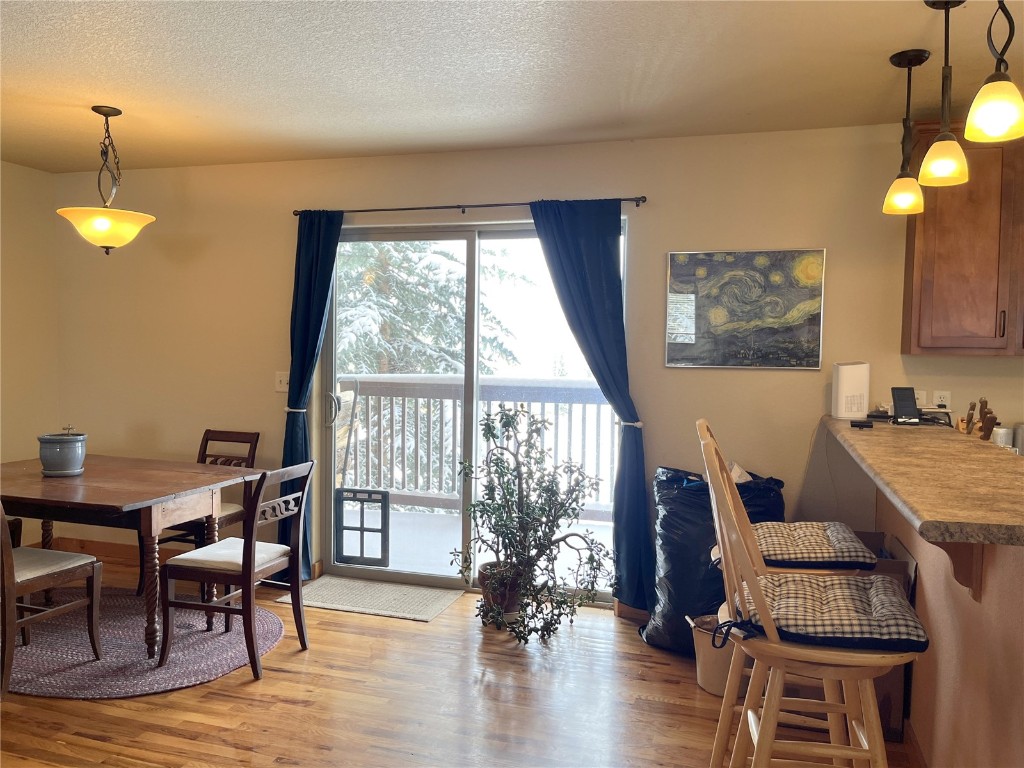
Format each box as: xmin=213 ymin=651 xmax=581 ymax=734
xmin=0 ymin=455 xmax=262 ymax=658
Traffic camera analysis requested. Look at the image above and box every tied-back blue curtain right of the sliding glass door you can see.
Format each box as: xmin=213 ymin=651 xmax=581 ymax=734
xmin=529 ymin=199 xmax=655 ymax=610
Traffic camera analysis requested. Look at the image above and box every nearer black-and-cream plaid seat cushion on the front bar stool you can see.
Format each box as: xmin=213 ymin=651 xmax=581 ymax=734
xmin=743 ymin=573 xmax=928 ymax=652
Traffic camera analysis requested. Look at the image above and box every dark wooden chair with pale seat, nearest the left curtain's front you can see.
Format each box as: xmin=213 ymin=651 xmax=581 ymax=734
xmin=158 ymin=461 xmax=315 ymax=680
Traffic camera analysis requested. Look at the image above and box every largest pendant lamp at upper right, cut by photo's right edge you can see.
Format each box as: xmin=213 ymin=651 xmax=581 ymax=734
xmin=964 ymin=0 xmax=1024 ymax=142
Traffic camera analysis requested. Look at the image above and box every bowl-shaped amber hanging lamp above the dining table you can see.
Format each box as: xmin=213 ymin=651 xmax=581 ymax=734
xmin=57 ymin=106 xmax=157 ymax=255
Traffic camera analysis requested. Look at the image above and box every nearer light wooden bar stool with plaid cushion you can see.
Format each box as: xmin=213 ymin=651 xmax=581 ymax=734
xmin=697 ymin=420 xmax=928 ymax=768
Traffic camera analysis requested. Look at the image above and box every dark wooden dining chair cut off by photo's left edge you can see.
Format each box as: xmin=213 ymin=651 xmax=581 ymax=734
xmin=0 ymin=505 xmax=103 ymax=696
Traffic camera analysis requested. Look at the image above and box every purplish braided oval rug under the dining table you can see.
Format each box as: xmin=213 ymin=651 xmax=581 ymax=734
xmin=10 ymin=588 xmax=285 ymax=698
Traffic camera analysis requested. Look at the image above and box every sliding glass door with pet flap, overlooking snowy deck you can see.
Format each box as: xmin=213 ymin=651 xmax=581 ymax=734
xmin=322 ymin=228 xmax=617 ymax=586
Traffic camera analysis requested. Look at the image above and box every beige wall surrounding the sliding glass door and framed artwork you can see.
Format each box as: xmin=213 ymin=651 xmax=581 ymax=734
xmin=2 ymin=125 xmax=1024 ymax=535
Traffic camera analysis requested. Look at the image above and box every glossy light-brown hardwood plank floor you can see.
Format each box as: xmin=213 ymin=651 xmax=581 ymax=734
xmin=0 ymin=562 xmax=925 ymax=768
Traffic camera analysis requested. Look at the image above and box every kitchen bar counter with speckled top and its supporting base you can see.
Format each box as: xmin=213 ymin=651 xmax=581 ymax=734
xmin=819 ymin=417 xmax=1024 ymax=768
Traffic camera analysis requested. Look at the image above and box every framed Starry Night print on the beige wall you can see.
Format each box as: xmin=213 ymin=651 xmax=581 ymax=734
xmin=665 ymin=249 xmax=825 ymax=370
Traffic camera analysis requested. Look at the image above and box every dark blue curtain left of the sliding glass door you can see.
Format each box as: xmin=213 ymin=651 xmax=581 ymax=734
xmin=278 ymin=211 xmax=344 ymax=580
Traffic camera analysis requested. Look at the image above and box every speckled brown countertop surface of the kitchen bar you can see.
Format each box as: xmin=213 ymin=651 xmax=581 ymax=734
xmin=822 ymin=416 xmax=1024 ymax=546
